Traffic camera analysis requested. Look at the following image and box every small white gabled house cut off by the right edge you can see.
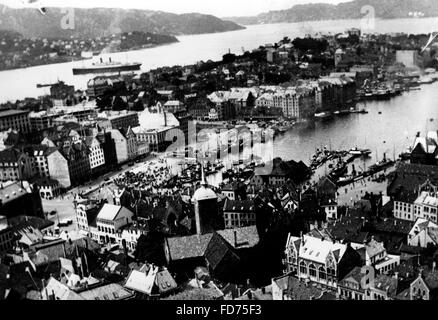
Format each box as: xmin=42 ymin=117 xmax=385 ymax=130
xmin=408 ymin=218 xmax=438 ymax=248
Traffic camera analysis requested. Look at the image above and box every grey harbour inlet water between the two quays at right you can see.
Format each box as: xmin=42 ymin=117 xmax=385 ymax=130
xmin=274 ymin=83 xmax=438 ymax=163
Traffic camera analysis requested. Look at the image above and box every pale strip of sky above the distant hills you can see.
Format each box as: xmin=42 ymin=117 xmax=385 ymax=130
xmin=0 ymin=0 xmax=351 ymax=17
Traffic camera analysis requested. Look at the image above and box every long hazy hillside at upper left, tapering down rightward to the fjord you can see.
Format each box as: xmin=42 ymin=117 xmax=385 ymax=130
xmin=0 ymin=4 xmax=244 ymax=38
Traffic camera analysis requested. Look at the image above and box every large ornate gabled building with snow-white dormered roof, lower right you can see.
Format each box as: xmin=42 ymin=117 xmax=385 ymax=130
xmin=285 ymin=234 xmax=361 ymax=288
